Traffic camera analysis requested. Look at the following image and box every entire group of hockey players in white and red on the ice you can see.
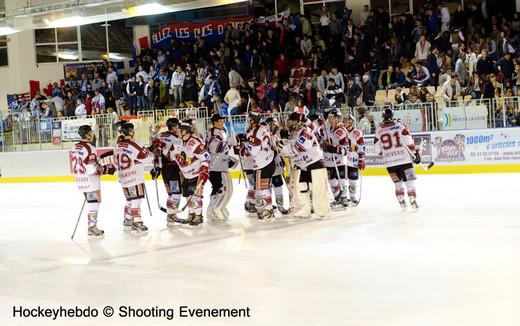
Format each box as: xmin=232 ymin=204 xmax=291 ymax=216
xmin=71 ymin=109 xmax=421 ymax=237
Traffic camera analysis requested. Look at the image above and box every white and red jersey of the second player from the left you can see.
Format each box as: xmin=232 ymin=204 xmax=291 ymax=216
xmin=114 ymin=139 xmax=153 ymax=188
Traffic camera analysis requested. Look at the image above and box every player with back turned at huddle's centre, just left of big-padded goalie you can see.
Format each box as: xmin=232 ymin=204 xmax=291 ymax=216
xmin=246 ymin=112 xmax=275 ymax=220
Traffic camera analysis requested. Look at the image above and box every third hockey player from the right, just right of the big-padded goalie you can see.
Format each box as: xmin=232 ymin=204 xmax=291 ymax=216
xmin=323 ymin=109 xmax=349 ymax=207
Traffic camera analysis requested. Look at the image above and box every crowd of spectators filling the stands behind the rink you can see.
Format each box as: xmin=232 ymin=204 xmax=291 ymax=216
xmin=4 ymin=1 xmax=520 ymax=128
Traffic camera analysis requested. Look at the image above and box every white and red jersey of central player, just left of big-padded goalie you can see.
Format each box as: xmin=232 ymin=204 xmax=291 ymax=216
xmin=246 ymin=124 xmax=274 ymax=170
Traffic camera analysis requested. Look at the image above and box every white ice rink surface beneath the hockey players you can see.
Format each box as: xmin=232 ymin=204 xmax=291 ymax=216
xmin=0 ymin=174 xmax=520 ymax=326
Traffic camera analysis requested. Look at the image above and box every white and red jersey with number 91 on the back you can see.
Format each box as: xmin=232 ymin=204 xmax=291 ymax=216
xmin=374 ymin=121 xmax=415 ymax=167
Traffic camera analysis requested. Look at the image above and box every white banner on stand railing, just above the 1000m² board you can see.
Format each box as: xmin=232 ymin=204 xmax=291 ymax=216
xmin=441 ymin=105 xmax=488 ymax=130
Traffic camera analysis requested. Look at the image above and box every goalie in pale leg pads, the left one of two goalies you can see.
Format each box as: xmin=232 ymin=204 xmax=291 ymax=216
xmin=206 ymin=114 xmax=234 ymax=221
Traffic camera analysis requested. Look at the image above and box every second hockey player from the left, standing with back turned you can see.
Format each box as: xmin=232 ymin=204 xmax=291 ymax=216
xmin=114 ymin=123 xmax=153 ymax=232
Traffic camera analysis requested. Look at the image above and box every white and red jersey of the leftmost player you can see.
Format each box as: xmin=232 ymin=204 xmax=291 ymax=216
xmin=70 ymin=141 xmax=103 ymax=192
